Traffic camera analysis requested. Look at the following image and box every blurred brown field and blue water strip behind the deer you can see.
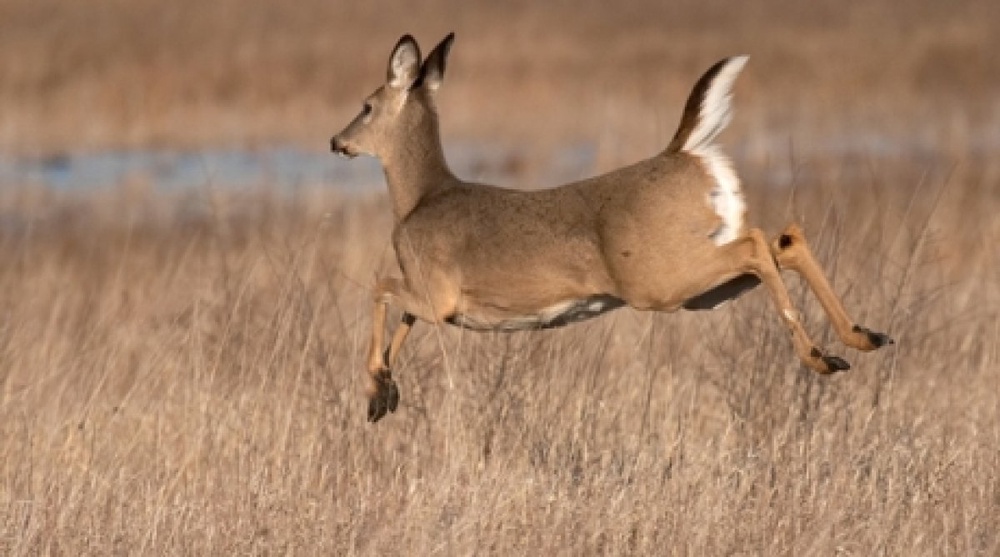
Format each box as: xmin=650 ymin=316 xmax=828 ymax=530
xmin=0 ymin=0 xmax=1000 ymax=187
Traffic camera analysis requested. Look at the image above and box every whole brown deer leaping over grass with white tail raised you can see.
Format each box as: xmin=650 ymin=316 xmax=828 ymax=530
xmin=330 ymin=33 xmax=893 ymax=423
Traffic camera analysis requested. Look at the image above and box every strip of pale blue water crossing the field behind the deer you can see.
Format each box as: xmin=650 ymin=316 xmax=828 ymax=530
xmin=0 ymin=134 xmax=988 ymax=192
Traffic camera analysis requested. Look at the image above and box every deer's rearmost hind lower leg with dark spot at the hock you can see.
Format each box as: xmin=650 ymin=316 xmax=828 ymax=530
xmin=771 ymin=224 xmax=893 ymax=351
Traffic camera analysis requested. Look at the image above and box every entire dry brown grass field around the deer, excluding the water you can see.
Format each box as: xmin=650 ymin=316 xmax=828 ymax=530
xmin=0 ymin=0 xmax=1000 ymax=555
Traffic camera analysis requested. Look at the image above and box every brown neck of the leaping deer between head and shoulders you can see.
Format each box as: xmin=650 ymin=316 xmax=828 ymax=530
xmin=382 ymin=122 xmax=455 ymax=221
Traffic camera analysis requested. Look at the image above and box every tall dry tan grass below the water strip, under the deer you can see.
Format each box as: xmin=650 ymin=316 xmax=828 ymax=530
xmin=0 ymin=148 xmax=1000 ymax=555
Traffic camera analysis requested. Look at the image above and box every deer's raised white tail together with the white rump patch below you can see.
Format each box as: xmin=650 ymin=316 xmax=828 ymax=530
xmin=667 ymin=56 xmax=748 ymax=245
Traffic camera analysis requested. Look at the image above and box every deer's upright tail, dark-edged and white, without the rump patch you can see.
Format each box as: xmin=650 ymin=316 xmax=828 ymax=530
xmin=667 ymin=56 xmax=749 ymax=154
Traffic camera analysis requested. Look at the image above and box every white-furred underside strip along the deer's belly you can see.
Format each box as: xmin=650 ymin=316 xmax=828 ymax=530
xmin=446 ymin=294 xmax=625 ymax=331
